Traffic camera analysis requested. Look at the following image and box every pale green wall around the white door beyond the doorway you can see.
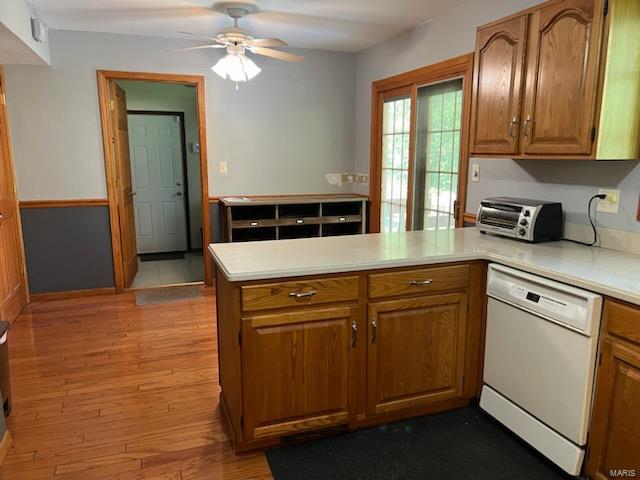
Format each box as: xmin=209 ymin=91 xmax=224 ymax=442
xmin=118 ymin=81 xmax=202 ymax=248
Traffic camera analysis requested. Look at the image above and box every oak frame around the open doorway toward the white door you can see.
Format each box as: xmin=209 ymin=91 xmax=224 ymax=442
xmin=97 ymin=70 xmax=213 ymax=293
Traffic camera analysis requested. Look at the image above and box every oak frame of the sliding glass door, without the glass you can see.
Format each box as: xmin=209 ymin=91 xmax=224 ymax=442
xmin=369 ymin=53 xmax=474 ymax=233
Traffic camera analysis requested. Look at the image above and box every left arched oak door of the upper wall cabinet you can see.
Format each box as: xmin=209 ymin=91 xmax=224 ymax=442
xmin=471 ymin=15 xmax=528 ymax=155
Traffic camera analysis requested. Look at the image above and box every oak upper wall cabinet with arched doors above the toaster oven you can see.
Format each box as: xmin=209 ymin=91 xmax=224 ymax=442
xmin=470 ymin=0 xmax=640 ymax=160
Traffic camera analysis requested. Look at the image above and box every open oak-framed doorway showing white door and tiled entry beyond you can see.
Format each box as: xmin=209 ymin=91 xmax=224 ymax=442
xmin=98 ymin=71 xmax=211 ymax=291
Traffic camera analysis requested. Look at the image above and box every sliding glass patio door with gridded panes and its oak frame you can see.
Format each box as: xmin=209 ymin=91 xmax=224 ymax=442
xmin=369 ymin=55 xmax=473 ymax=232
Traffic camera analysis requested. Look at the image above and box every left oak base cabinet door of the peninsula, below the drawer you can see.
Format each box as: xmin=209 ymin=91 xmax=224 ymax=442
xmin=242 ymin=306 xmax=357 ymax=440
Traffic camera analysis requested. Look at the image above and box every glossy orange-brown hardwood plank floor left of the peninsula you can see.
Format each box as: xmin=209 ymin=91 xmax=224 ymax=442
xmin=0 ymin=289 xmax=271 ymax=480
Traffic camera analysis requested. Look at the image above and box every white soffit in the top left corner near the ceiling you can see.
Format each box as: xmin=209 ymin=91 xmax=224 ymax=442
xmin=0 ymin=0 xmax=49 ymax=65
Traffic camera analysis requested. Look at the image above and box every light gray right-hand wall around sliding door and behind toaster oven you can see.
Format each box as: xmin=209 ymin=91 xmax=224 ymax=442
xmin=355 ymin=0 xmax=640 ymax=231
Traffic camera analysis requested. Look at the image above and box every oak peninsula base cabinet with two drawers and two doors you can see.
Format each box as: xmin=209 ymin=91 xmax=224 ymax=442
xmin=216 ymin=262 xmax=486 ymax=452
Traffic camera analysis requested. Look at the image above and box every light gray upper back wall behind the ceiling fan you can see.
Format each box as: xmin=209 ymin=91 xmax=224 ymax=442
xmin=6 ymin=31 xmax=355 ymax=200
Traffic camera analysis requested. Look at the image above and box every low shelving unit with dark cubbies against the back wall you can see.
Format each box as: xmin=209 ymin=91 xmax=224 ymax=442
xmin=220 ymin=195 xmax=368 ymax=242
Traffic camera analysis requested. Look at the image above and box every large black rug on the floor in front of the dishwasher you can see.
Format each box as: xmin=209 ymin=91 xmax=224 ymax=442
xmin=267 ymin=407 xmax=575 ymax=480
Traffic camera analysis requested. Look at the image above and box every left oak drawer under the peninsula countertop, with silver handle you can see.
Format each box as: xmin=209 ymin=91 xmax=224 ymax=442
xmin=242 ymin=277 xmax=358 ymax=312
